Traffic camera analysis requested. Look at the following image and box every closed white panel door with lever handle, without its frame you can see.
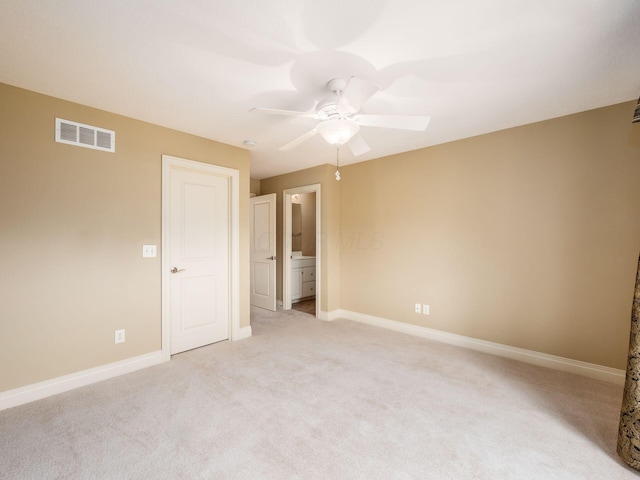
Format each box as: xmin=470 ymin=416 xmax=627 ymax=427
xmin=169 ymin=168 xmax=230 ymax=354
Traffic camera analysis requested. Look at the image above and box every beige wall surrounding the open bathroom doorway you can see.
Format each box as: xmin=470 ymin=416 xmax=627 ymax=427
xmin=260 ymin=165 xmax=340 ymax=312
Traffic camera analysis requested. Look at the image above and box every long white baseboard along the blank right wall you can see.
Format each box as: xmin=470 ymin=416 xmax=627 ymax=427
xmin=336 ymin=310 xmax=625 ymax=385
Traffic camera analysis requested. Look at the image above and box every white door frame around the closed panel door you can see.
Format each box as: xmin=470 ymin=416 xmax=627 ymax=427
xmin=161 ymin=155 xmax=240 ymax=361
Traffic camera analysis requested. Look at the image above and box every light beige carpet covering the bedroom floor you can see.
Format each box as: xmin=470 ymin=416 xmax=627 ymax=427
xmin=0 ymin=309 xmax=640 ymax=480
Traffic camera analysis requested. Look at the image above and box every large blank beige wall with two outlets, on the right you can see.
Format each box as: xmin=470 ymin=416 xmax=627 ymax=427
xmin=340 ymin=102 xmax=640 ymax=368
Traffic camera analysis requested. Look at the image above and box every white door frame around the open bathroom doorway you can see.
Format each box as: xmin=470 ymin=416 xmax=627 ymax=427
xmin=282 ymin=183 xmax=323 ymax=318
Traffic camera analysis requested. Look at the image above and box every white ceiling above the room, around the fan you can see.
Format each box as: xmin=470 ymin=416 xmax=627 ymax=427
xmin=0 ymin=0 xmax=640 ymax=178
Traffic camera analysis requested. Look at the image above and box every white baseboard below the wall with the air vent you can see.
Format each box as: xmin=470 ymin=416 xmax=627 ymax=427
xmin=0 ymin=350 xmax=165 ymax=410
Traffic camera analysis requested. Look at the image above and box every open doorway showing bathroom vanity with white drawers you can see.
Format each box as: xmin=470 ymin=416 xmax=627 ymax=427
xmin=282 ymin=184 xmax=322 ymax=317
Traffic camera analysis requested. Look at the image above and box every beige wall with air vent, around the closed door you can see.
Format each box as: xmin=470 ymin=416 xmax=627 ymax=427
xmin=0 ymin=84 xmax=249 ymax=390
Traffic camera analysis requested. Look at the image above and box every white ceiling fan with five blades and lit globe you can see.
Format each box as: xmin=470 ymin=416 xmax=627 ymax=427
xmin=251 ymin=77 xmax=429 ymax=156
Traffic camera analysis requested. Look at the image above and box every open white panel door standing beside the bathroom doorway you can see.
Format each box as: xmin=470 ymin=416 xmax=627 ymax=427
xmin=250 ymin=193 xmax=276 ymax=311
